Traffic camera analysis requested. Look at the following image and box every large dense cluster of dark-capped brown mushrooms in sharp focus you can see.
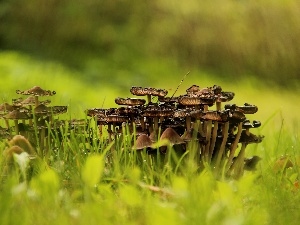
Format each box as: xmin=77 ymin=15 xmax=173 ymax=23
xmin=86 ymin=85 xmax=263 ymax=178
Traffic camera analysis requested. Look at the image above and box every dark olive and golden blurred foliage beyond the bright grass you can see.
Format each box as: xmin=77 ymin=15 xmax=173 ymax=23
xmin=0 ymin=0 xmax=300 ymax=86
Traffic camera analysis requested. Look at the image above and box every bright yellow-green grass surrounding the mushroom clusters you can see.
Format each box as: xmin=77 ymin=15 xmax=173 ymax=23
xmin=0 ymin=53 xmax=300 ymax=224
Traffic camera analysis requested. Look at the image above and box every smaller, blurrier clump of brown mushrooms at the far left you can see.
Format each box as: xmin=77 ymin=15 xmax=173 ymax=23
xmin=0 ymin=86 xmax=82 ymax=150
